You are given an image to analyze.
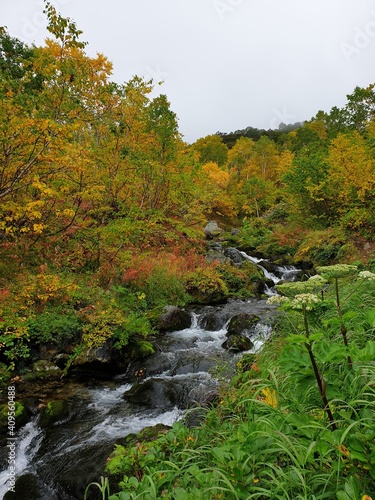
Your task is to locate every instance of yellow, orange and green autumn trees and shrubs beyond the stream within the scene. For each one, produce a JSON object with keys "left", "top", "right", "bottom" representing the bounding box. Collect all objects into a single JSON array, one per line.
[{"left": 0, "top": 2, "right": 375, "bottom": 378}]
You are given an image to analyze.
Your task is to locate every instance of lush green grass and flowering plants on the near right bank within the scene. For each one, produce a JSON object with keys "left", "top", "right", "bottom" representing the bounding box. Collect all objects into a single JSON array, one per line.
[{"left": 87, "top": 266, "right": 375, "bottom": 500}]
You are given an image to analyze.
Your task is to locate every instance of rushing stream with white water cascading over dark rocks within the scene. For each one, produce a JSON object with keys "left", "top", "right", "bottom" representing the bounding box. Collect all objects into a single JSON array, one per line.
[{"left": 0, "top": 252, "right": 299, "bottom": 500}]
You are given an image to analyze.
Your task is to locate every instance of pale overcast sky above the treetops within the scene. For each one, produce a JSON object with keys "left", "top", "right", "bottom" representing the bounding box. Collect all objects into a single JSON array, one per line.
[{"left": 0, "top": 0, "right": 375, "bottom": 142}]
